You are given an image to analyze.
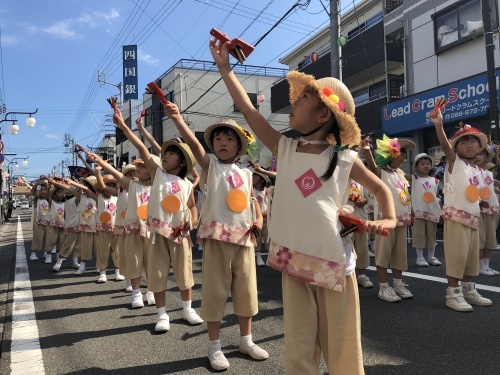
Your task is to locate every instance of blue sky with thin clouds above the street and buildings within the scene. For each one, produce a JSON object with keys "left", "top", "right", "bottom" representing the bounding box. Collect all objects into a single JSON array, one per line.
[{"left": 0, "top": 0, "right": 357, "bottom": 178}]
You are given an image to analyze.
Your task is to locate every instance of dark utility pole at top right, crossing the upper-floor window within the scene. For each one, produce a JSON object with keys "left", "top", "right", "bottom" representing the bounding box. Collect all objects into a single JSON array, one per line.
[{"left": 481, "top": 0, "right": 500, "bottom": 141}]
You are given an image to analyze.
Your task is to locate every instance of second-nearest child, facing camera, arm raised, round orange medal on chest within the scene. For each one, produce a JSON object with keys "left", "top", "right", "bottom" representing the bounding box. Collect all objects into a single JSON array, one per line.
[{"left": 165, "top": 103, "right": 269, "bottom": 370}]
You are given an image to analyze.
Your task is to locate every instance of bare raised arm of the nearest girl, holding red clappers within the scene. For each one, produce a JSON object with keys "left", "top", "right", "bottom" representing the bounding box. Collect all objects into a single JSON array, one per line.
[{"left": 210, "top": 40, "right": 282, "bottom": 155}]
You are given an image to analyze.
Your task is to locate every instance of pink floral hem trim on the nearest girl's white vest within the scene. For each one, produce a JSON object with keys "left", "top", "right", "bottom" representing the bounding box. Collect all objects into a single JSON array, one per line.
[{"left": 267, "top": 241, "right": 346, "bottom": 292}]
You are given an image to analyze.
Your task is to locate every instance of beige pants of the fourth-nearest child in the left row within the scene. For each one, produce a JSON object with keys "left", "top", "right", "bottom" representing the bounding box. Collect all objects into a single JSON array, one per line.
[{"left": 124, "top": 233, "right": 149, "bottom": 284}]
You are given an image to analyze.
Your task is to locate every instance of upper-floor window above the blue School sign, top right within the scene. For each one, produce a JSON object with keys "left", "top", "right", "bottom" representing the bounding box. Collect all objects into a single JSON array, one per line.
[{"left": 433, "top": 0, "right": 498, "bottom": 52}]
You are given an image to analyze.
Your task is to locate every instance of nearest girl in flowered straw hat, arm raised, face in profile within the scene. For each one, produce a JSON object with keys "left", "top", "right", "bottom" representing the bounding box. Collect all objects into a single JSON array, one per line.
[{"left": 210, "top": 36, "right": 396, "bottom": 374}]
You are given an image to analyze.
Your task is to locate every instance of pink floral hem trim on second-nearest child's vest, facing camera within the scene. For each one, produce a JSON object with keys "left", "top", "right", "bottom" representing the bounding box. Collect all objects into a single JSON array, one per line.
[{"left": 197, "top": 221, "right": 257, "bottom": 247}]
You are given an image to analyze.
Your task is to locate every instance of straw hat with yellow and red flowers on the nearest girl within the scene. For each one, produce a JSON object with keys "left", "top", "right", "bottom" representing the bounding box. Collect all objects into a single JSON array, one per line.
[{"left": 286, "top": 71, "right": 361, "bottom": 147}]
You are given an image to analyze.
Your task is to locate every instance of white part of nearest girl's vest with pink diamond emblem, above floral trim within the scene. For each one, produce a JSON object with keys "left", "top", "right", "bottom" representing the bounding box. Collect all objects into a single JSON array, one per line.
[{"left": 269, "top": 136, "right": 356, "bottom": 265}]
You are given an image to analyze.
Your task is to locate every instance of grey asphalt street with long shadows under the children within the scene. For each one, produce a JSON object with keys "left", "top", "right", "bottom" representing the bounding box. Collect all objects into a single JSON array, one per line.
[{"left": 0, "top": 210, "right": 500, "bottom": 375}]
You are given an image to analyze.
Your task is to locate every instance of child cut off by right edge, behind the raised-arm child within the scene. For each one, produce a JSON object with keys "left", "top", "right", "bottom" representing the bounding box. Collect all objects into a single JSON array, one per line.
[{"left": 475, "top": 145, "right": 500, "bottom": 276}]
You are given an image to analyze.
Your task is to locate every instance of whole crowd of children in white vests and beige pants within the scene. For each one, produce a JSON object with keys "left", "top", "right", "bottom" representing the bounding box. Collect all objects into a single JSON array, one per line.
[{"left": 18, "top": 36, "right": 500, "bottom": 374}]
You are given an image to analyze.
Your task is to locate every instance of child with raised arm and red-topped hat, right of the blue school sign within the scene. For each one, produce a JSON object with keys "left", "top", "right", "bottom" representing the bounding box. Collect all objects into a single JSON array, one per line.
[{"left": 430, "top": 108, "right": 492, "bottom": 311}]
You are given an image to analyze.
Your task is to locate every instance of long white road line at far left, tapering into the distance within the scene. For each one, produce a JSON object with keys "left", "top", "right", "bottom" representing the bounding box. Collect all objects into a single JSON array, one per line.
[{"left": 10, "top": 216, "right": 45, "bottom": 375}]
